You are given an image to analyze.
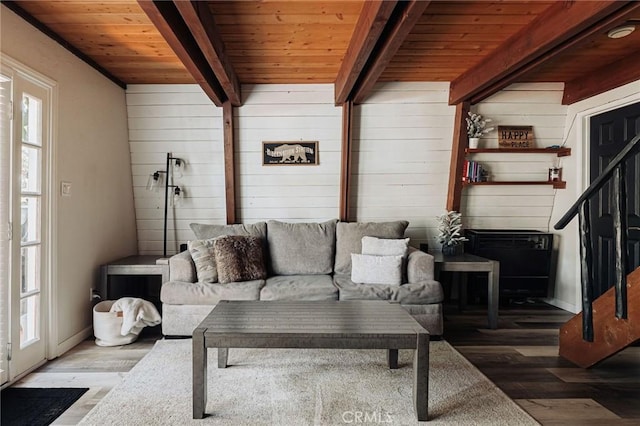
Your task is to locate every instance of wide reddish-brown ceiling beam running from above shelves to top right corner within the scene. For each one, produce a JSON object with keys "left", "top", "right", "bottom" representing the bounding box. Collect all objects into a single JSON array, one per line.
[{"left": 449, "top": 0, "right": 640, "bottom": 105}]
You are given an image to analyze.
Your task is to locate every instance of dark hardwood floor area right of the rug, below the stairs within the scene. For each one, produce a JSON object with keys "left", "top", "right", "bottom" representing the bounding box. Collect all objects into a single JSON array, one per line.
[{"left": 444, "top": 303, "right": 640, "bottom": 425}]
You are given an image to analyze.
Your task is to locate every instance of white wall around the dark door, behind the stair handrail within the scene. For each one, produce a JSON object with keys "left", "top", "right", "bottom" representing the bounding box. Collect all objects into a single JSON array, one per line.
[{"left": 551, "top": 81, "right": 640, "bottom": 312}]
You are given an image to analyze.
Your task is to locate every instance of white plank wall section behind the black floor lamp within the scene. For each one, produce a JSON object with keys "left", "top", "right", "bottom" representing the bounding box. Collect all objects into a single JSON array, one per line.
[{"left": 127, "top": 84, "right": 226, "bottom": 254}]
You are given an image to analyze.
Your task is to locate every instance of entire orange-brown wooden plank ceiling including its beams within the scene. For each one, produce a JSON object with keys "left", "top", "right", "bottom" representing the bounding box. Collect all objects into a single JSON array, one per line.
[{"left": 3, "top": 0, "right": 640, "bottom": 105}]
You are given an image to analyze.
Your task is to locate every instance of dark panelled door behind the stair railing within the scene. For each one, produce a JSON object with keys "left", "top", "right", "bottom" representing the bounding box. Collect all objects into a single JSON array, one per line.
[{"left": 590, "top": 103, "right": 640, "bottom": 297}]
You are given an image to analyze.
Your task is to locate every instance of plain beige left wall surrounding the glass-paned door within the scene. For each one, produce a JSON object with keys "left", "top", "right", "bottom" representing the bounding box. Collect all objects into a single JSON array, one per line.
[{"left": 0, "top": 6, "right": 137, "bottom": 356}]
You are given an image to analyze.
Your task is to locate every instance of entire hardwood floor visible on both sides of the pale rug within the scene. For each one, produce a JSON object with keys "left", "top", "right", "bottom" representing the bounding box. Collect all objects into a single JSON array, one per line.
[{"left": 10, "top": 303, "right": 640, "bottom": 425}]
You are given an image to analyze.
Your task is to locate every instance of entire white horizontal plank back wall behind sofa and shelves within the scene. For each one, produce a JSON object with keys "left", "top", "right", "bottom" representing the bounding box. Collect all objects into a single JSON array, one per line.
[{"left": 127, "top": 83, "right": 566, "bottom": 254}]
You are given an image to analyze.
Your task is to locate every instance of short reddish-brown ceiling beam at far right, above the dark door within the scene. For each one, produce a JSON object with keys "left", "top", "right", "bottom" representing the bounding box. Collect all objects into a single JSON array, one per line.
[{"left": 562, "top": 52, "right": 640, "bottom": 105}]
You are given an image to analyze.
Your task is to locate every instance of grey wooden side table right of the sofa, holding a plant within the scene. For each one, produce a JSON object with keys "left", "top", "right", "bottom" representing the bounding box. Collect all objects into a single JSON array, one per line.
[{"left": 429, "top": 251, "right": 500, "bottom": 329}]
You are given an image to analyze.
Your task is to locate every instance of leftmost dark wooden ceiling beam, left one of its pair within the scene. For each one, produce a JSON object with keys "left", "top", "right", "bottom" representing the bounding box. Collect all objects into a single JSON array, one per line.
[{"left": 138, "top": 0, "right": 227, "bottom": 107}]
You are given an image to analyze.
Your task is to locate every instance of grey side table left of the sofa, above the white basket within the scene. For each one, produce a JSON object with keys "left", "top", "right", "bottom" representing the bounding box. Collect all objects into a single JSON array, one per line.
[{"left": 99, "top": 255, "right": 169, "bottom": 300}]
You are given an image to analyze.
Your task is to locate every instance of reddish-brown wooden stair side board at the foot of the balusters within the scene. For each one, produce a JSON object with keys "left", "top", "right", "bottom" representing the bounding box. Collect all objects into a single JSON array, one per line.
[{"left": 560, "top": 268, "right": 640, "bottom": 368}]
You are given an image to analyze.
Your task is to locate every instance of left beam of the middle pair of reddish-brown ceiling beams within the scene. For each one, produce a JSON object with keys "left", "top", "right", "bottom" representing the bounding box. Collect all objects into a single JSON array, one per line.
[{"left": 335, "top": 0, "right": 398, "bottom": 105}]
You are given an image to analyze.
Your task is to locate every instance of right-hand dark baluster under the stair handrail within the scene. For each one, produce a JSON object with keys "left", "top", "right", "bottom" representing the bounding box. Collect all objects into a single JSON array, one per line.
[{"left": 611, "top": 161, "right": 628, "bottom": 319}]
